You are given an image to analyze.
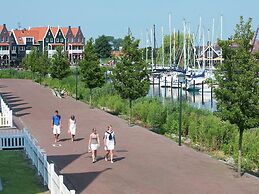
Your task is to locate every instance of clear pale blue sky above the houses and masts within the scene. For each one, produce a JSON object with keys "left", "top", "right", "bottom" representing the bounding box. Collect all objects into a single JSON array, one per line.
[{"left": 0, "top": 0, "right": 259, "bottom": 44}]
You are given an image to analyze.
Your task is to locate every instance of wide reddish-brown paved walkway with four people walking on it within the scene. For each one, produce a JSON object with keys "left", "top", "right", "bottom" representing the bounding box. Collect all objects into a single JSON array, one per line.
[{"left": 0, "top": 80, "right": 259, "bottom": 194}]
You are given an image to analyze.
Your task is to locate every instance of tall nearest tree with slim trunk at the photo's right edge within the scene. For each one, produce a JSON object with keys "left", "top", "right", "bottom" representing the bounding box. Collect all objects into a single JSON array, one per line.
[{"left": 215, "top": 17, "right": 259, "bottom": 174}]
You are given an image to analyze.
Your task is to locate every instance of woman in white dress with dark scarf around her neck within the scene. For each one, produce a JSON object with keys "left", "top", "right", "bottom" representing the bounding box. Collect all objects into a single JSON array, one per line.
[{"left": 103, "top": 125, "right": 116, "bottom": 163}]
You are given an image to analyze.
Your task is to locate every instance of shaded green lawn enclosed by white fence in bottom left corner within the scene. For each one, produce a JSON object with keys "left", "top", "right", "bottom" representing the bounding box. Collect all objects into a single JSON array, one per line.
[{"left": 0, "top": 151, "right": 49, "bottom": 194}]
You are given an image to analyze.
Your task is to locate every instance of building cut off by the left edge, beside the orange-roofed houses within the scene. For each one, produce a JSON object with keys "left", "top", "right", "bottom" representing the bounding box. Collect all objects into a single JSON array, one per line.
[{"left": 0, "top": 24, "right": 10, "bottom": 65}]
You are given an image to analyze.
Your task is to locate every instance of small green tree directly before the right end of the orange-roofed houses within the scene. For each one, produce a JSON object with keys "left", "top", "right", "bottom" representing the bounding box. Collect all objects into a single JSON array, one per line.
[{"left": 50, "top": 47, "right": 70, "bottom": 89}]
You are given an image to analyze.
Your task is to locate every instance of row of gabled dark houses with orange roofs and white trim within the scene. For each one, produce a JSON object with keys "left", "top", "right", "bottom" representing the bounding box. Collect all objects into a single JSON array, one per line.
[{"left": 10, "top": 26, "right": 85, "bottom": 64}]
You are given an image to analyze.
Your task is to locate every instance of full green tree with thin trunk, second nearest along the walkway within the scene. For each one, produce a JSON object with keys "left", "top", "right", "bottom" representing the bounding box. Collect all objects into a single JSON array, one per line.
[{"left": 112, "top": 35, "right": 149, "bottom": 124}]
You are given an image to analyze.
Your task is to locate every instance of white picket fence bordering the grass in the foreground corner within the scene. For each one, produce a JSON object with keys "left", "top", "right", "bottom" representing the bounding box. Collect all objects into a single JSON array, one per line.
[{"left": 0, "top": 129, "right": 75, "bottom": 194}]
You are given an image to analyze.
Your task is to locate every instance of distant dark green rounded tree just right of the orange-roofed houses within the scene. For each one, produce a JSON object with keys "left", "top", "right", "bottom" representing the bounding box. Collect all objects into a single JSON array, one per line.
[{"left": 94, "top": 35, "right": 112, "bottom": 58}]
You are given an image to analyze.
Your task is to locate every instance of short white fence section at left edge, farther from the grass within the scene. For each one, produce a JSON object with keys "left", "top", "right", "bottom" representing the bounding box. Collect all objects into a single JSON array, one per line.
[{"left": 0, "top": 96, "right": 13, "bottom": 127}]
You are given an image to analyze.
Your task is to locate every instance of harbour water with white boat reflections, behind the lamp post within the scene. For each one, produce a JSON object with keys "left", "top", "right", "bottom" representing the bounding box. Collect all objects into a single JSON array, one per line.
[{"left": 148, "top": 85, "right": 217, "bottom": 112}]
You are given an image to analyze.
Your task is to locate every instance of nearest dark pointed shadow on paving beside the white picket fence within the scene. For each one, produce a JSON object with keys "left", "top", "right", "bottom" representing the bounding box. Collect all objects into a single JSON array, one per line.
[{"left": 63, "top": 168, "right": 112, "bottom": 193}]
